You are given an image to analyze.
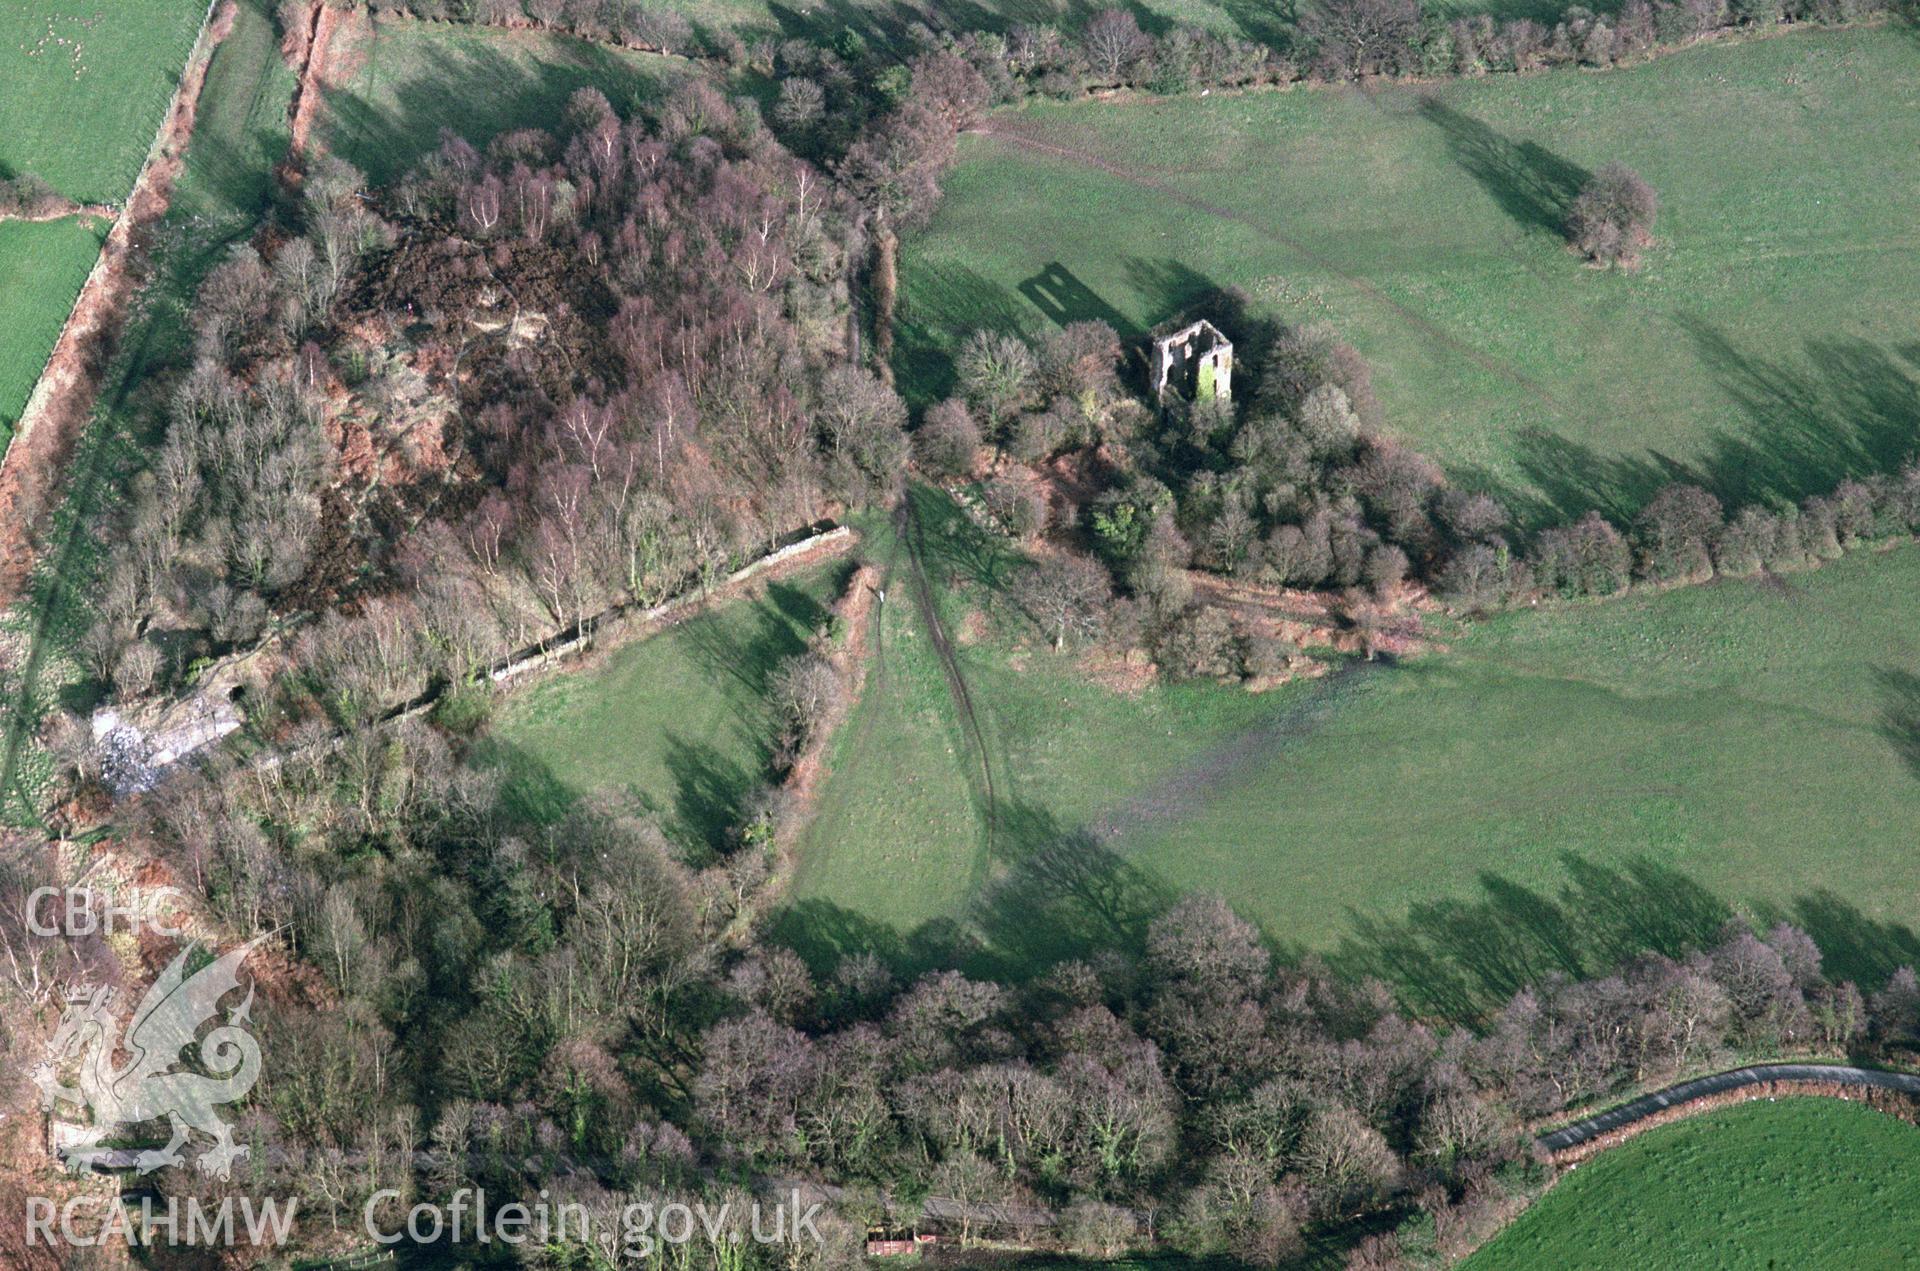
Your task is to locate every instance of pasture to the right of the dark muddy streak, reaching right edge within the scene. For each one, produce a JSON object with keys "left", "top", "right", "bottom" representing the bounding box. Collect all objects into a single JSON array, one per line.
[{"left": 1121, "top": 547, "right": 1920, "bottom": 1012}]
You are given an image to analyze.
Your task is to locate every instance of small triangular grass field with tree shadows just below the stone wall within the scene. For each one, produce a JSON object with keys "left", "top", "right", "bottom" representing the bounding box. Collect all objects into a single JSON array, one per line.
[{"left": 484, "top": 564, "right": 847, "bottom": 851}]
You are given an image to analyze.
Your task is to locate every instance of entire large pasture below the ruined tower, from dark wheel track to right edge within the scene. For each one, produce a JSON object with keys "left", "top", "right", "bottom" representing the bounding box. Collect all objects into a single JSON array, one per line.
[{"left": 785, "top": 487, "right": 1920, "bottom": 1016}]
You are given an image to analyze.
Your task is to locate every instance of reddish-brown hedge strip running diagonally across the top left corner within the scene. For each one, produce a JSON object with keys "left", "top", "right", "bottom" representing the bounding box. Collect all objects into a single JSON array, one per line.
[{"left": 0, "top": 0, "right": 234, "bottom": 603}]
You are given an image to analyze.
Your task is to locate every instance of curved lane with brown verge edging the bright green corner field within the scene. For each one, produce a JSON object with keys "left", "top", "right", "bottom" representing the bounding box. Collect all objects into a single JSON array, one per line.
[{"left": 1534, "top": 1064, "right": 1920, "bottom": 1163}]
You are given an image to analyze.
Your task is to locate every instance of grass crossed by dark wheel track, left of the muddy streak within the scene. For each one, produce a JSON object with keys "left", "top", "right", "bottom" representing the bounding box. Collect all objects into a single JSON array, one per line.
[{"left": 785, "top": 490, "right": 1275, "bottom": 973}]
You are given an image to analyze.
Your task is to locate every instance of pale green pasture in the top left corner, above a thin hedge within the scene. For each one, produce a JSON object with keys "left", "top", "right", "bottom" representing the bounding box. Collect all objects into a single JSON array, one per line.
[{"left": 0, "top": 0, "right": 207, "bottom": 204}]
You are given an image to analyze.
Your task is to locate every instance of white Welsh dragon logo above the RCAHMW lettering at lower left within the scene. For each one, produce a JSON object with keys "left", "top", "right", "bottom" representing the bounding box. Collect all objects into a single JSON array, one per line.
[{"left": 33, "top": 937, "right": 265, "bottom": 1179}]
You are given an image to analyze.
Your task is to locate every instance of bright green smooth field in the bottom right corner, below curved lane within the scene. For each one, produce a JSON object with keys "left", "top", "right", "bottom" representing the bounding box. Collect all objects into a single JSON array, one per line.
[{"left": 1465, "top": 1098, "right": 1920, "bottom": 1271}]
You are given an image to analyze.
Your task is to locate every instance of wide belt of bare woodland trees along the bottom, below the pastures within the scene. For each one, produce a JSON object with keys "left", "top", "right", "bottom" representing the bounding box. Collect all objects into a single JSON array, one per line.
[{"left": 18, "top": 710, "right": 1920, "bottom": 1271}]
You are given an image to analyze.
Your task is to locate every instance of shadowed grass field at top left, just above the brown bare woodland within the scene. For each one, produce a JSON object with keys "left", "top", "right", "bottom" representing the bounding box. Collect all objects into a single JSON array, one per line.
[{"left": 319, "top": 21, "right": 687, "bottom": 184}]
